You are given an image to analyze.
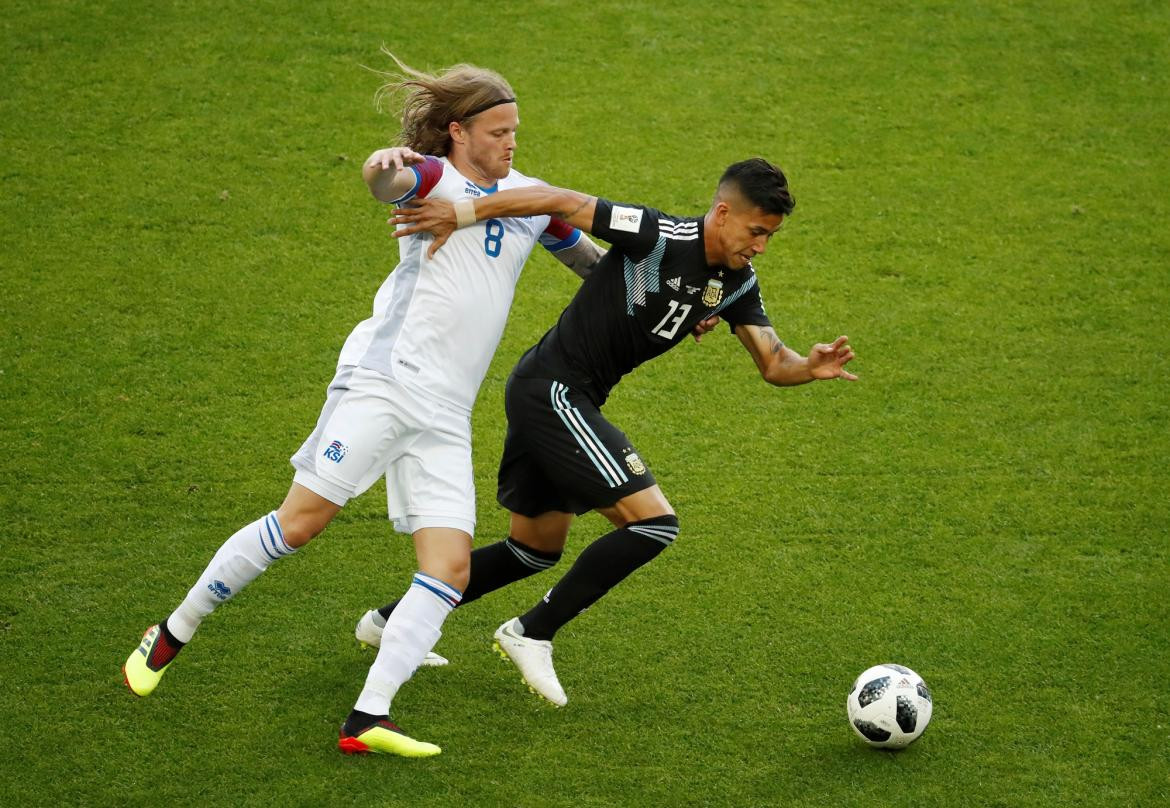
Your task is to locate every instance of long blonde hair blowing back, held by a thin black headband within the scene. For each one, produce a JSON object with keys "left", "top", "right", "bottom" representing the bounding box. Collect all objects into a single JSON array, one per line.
[{"left": 374, "top": 47, "right": 515, "bottom": 157}]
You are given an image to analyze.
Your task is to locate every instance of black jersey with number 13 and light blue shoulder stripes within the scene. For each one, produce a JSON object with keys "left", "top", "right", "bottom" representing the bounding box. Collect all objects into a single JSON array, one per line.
[{"left": 514, "top": 199, "right": 771, "bottom": 407}]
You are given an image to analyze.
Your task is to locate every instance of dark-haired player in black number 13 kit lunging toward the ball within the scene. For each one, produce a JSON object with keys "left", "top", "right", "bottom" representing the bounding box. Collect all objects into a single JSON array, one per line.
[{"left": 379, "top": 158, "right": 856, "bottom": 705}]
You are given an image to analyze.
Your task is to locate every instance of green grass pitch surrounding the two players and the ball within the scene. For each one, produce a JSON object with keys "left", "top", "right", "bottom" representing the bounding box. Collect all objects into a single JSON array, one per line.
[{"left": 0, "top": 0, "right": 1170, "bottom": 808}]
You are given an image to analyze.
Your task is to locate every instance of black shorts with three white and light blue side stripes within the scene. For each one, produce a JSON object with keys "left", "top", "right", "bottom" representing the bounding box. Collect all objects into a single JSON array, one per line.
[{"left": 496, "top": 375, "right": 656, "bottom": 517}]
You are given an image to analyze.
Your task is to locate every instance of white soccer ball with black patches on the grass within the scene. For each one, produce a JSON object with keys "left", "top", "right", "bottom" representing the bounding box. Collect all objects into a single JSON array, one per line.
[{"left": 845, "top": 663, "right": 934, "bottom": 750}]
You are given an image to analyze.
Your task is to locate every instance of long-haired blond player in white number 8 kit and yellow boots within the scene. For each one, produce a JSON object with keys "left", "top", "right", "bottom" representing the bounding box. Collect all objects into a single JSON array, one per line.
[{"left": 123, "top": 58, "right": 603, "bottom": 757}]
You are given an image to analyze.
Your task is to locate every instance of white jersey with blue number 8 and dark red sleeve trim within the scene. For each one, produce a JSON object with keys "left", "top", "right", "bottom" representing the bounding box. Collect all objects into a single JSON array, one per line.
[{"left": 338, "top": 157, "right": 580, "bottom": 412}]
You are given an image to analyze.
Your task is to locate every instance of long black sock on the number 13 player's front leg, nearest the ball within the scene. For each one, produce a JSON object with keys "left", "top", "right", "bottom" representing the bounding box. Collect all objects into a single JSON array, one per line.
[{"left": 519, "top": 516, "right": 679, "bottom": 640}]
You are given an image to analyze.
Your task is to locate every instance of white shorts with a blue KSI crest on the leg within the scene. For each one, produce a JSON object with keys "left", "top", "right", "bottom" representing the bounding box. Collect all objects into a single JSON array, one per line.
[{"left": 291, "top": 366, "right": 475, "bottom": 534}]
